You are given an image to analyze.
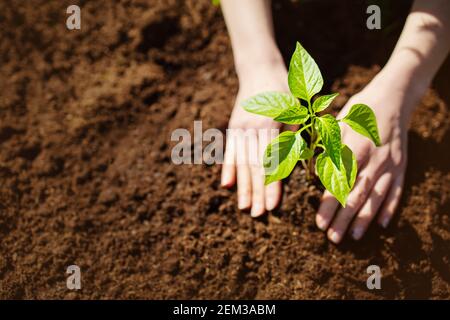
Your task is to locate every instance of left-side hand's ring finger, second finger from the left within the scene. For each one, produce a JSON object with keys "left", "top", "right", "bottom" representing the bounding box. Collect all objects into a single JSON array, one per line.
[{"left": 236, "top": 134, "right": 252, "bottom": 210}]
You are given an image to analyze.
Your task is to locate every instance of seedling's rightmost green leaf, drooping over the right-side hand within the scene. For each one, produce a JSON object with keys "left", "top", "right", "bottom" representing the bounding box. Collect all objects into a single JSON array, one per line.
[{"left": 342, "top": 104, "right": 381, "bottom": 147}]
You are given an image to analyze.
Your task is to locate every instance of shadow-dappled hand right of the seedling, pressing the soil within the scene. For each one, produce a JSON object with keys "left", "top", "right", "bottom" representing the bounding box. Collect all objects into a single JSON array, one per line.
[{"left": 316, "top": 71, "right": 420, "bottom": 244}]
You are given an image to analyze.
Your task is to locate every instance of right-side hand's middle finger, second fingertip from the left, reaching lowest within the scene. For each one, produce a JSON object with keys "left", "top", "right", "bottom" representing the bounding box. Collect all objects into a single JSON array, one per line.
[{"left": 327, "top": 170, "right": 376, "bottom": 244}]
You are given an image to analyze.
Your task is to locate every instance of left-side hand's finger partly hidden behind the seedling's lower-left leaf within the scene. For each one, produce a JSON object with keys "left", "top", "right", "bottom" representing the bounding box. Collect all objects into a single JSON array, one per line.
[{"left": 258, "top": 129, "right": 282, "bottom": 211}]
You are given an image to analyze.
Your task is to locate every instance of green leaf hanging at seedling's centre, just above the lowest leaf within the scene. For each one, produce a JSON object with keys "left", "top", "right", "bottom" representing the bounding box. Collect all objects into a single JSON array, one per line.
[{"left": 316, "top": 114, "right": 341, "bottom": 168}]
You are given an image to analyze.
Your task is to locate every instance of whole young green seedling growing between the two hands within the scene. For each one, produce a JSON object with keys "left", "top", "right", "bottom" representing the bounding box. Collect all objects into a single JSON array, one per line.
[{"left": 242, "top": 42, "right": 381, "bottom": 207}]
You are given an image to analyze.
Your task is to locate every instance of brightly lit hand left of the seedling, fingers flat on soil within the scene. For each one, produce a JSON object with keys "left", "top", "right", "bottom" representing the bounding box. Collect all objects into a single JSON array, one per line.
[{"left": 221, "top": 63, "right": 289, "bottom": 217}]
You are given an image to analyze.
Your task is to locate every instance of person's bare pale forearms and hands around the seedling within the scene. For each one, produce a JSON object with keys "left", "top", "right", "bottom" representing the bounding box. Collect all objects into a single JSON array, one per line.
[{"left": 221, "top": 0, "right": 450, "bottom": 244}]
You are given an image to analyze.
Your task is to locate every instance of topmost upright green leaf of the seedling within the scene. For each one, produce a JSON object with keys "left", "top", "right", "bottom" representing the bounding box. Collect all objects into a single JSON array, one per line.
[{"left": 288, "top": 42, "right": 323, "bottom": 101}]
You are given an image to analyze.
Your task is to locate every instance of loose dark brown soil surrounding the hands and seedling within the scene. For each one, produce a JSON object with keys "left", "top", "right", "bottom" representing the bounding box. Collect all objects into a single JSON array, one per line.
[{"left": 0, "top": 0, "right": 450, "bottom": 299}]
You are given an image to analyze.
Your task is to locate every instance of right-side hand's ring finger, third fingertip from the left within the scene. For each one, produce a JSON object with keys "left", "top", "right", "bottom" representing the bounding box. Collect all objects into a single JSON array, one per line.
[{"left": 351, "top": 172, "right": 392, "bottom": 240}]
